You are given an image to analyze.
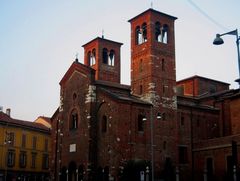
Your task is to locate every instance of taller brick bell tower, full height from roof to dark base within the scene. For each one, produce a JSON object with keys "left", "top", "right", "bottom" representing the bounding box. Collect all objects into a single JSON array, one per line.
[{"left": 129, "top": 9, "right": 177, "bottom": 171}]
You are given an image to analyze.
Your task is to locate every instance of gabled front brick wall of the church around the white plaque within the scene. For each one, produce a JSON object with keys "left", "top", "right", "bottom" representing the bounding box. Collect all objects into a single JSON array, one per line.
[{"left": 59, "top": 71, "right": 91, "bottom": 174}]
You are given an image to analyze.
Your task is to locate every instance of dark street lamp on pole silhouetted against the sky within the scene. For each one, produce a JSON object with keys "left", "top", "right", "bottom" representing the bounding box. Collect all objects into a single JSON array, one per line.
[{"left": 213, "top": 29, "right": 240, "bottom": 86}]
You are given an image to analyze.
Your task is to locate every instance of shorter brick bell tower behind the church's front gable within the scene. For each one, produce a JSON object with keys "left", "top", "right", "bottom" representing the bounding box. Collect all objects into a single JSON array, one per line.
[{"left": 83, "top": 37, "right": 122, "bottom": 83}]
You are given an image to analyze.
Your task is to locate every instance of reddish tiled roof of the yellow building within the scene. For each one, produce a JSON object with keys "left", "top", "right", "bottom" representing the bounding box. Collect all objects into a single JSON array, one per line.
[{"left": 0, "top": 112, "right": 50, "bottom": 133}]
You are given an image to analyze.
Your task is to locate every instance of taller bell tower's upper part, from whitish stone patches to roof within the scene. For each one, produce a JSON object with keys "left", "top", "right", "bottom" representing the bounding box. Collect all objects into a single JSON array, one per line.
[{"left": 129, "top": 9, "right": 177, "bottom": 99}]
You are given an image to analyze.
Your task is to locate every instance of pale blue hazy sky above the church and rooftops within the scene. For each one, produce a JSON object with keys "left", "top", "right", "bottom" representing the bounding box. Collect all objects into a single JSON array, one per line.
[{"left": 0, "top": 0, "right": 240, "bottom": 121}]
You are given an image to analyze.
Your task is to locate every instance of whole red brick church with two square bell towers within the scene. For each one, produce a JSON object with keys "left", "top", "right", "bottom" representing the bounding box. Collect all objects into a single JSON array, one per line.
[{"left": 50, "top": 9, "right": 240, "bottom": 181}]
